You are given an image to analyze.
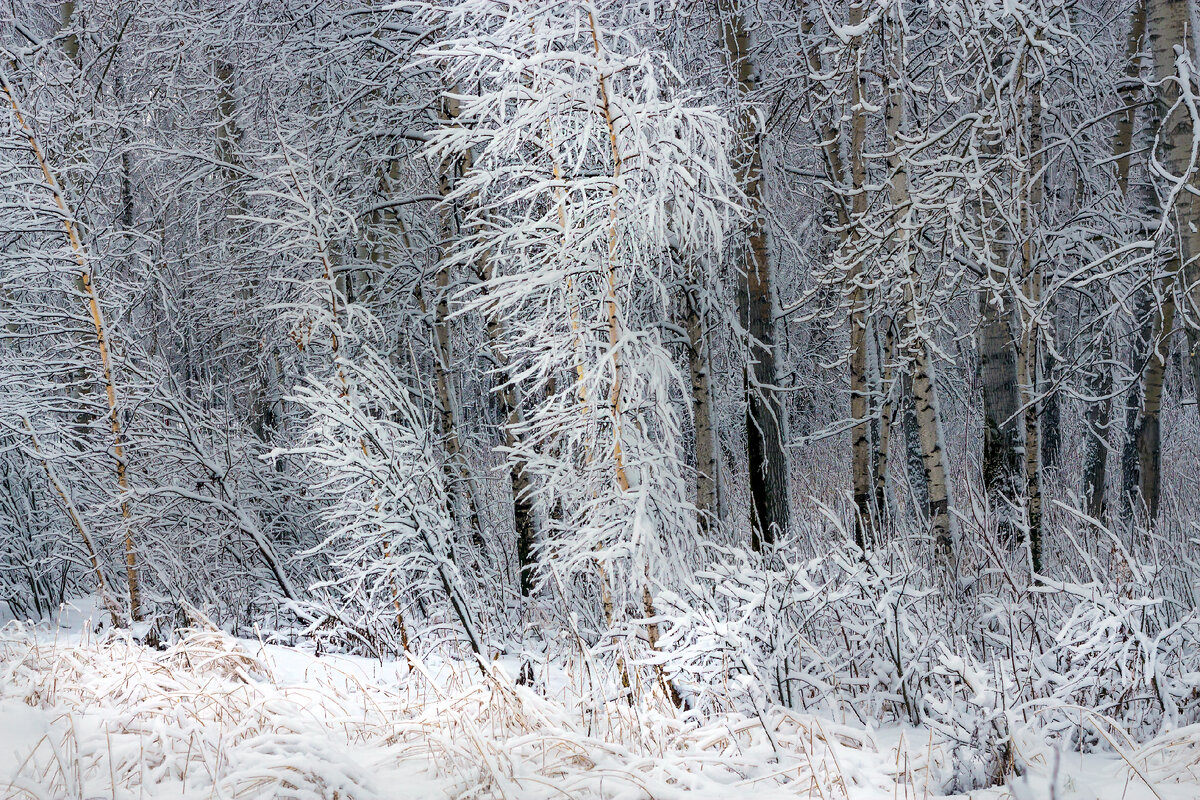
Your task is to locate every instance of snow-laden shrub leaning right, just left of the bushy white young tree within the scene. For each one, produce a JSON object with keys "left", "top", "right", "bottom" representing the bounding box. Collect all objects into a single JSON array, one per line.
[{"left": 288, "top": 347, "right": 482, "bottom": 655}]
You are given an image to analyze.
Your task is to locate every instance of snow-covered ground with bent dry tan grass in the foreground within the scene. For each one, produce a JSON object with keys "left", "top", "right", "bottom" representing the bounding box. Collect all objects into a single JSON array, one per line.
[{"left": 0, "top": 604, "right": 1200, "bottom": 800}]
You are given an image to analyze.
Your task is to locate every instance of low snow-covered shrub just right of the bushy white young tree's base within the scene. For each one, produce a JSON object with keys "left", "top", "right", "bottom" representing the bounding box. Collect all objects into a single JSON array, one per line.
[{"left": 664, "top": 527, "right": 938, "bottom": 722}]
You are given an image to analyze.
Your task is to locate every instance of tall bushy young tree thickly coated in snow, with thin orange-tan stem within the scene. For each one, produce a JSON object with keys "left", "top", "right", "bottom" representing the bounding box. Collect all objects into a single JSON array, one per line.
[{"left": 428, "top": 2, "right": 732, "bottom": 703}]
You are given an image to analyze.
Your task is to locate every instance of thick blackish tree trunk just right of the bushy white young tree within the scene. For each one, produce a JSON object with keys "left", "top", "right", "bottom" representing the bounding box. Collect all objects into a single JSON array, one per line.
[{"left": 718, "top": 0, "right": 790, "bottom": 551}]
